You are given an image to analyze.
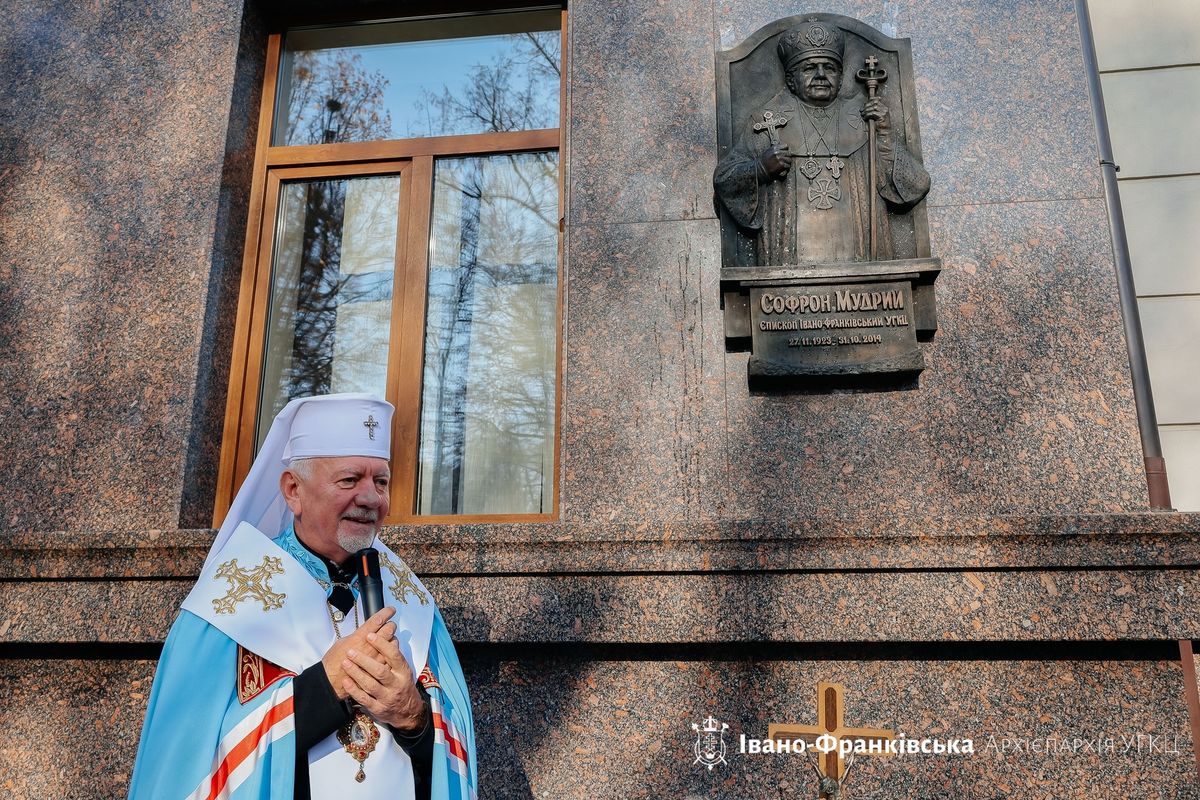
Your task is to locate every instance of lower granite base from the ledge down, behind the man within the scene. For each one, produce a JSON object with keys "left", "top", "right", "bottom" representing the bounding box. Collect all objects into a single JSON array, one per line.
[{"left": 7, "top": 513, "right": 1200, "bottom": 800}]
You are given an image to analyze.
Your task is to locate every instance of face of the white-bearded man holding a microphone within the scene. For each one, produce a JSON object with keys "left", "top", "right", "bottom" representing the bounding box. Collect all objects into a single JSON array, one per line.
[{"left": 280, "top": 456, "right": 391, "bottom": 561}]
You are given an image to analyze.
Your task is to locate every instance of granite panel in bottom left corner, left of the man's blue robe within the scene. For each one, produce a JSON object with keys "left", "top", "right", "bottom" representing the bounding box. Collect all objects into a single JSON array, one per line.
[{"left": 0, "top": 660, "right": 155, "bottom": 800}]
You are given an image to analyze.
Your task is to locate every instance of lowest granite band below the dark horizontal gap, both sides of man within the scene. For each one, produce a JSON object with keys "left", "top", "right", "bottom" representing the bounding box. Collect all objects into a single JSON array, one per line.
[{"left": 7, "top": 648, "right": 1200, "bottom": 800}]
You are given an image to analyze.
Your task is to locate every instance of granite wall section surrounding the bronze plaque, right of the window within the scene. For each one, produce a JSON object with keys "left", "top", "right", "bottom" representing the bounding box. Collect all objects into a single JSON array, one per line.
[{"left": 562, "top": 0, "right": 1147, "bottom": 522}]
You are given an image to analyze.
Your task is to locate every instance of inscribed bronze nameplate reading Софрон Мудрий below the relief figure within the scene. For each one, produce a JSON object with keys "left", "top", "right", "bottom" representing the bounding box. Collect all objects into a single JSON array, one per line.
[{"left": 750, "top": 281, "right": 923, "bottom": 377}]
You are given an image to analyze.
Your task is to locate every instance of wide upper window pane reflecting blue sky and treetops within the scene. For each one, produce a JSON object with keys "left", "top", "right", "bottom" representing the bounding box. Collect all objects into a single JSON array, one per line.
[{"left": 272, "top": 10, "right": 560, "bottom": 145}]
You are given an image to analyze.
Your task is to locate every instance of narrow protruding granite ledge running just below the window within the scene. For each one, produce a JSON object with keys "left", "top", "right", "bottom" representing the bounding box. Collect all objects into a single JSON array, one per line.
[{"left": 0, "top": 512, "right": 1200, "bottom": 581}]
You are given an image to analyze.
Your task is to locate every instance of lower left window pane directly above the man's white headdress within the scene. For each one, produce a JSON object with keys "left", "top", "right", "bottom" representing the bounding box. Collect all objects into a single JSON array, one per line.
[{"left": 256, "top": 175, "right": 401, "bottom": 450}]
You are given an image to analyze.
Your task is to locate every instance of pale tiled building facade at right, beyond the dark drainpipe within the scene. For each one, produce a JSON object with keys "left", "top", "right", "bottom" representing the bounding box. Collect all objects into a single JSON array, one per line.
[{"left": 1090, "top": 0, "right": 1200, "bottom": 511}]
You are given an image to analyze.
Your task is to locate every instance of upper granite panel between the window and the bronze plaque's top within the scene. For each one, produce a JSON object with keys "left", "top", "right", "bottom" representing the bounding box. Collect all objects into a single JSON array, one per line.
[{"left": 568, "top": 0, "right": 716, "bottom": 224}]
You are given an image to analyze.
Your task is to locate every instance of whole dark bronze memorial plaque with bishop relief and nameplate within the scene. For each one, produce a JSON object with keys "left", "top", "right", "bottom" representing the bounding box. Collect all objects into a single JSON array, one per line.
[{"left": 713, "top": 13, "right": 941, "bottom": 385}]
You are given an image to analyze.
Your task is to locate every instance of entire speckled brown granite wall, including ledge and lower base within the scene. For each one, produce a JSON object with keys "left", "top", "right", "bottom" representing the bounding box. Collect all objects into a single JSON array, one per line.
[{"left": 0, "top": 0, "right": 1200, "bottom": 800}]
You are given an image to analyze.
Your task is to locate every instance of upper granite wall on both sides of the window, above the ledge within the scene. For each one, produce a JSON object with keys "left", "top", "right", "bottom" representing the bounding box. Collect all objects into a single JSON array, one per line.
[{"left": 0, "top": 0, "right": 1147, "bottom": 531}]
